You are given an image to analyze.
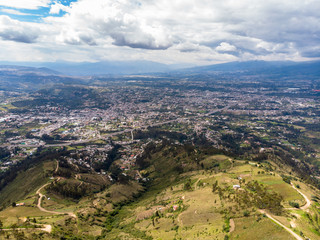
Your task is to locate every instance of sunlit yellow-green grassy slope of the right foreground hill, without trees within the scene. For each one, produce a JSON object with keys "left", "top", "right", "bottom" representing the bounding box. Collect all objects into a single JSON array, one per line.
[{"left": 102, "top": 156, "right": 312, "bottom": 239}]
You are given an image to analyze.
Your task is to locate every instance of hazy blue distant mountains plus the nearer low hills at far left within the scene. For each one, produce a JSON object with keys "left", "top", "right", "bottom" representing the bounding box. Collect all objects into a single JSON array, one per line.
[{"left": 0, "top": 61, "right": 320, "bottom": 91}]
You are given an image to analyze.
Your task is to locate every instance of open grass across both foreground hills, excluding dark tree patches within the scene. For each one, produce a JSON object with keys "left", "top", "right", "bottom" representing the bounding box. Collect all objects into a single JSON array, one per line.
[{"left": 0, "top": 149, "right": 318, "bottom": 239}]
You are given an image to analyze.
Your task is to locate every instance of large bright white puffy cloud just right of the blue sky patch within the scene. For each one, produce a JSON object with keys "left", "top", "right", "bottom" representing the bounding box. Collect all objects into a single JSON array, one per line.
[{"left": 47, "top": 0, "right": 172, "bottom": 49}]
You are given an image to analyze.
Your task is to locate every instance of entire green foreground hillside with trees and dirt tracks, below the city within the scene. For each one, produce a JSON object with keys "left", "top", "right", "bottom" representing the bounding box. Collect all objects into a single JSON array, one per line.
[{"left": 0, "top": 142, "right": 320, "bottom": 239}]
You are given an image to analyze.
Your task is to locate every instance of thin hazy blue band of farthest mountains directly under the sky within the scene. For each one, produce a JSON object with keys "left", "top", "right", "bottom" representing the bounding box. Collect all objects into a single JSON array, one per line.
[{"left": 0, "top": 61, "right": 320, "bottom": 76}]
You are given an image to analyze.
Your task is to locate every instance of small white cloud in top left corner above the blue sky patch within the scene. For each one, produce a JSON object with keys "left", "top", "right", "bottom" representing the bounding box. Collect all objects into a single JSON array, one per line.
[{"left": 0, "top": 0, "right": 52, "bottom": 9}]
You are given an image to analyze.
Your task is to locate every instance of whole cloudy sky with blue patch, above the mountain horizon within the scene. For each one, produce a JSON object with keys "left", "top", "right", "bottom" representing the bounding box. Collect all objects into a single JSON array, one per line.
[{"left": 0, "top": 0, "right": 320, "bottom": 65}]
